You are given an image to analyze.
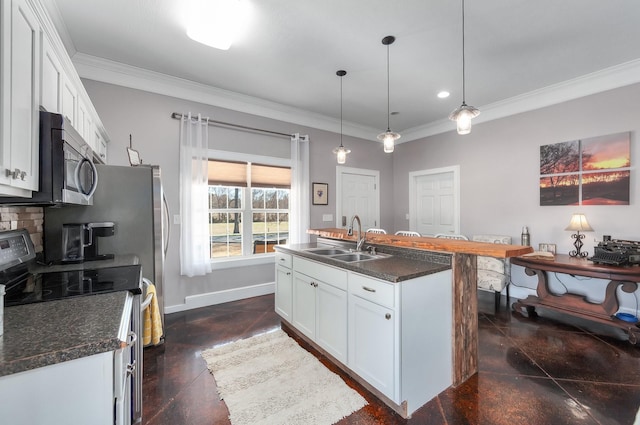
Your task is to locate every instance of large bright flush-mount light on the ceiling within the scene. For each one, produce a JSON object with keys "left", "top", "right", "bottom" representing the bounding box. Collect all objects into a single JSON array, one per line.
[{"left": 187, "top": 0, "right": 249, "bottom": 50}]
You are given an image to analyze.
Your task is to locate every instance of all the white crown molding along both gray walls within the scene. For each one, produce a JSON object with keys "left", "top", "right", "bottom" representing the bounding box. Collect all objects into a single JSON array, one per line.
[{"left": 72, "top": 53, "right": 640, "bottom": 144}]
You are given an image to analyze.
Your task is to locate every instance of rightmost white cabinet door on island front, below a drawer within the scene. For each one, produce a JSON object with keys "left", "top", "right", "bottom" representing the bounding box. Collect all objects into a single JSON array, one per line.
[{"left": 348, "top": 295, "right": 397, "bottom": 402}]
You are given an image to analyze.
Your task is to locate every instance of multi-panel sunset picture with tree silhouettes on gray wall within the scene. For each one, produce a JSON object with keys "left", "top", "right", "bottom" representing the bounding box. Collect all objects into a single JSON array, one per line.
[{"left": 540, "top": 132, "right": 631, "bottom": 206}]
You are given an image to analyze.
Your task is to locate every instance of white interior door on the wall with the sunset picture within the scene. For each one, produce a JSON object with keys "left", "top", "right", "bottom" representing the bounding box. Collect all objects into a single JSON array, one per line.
[{"left": 409, "top": 166, "right": 460, "bottom": 236}]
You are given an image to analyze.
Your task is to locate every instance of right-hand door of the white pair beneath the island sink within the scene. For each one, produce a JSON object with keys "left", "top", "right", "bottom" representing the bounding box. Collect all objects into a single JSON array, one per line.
[{"left": 316, "top": 282, "right": 347, "bottom": 363}]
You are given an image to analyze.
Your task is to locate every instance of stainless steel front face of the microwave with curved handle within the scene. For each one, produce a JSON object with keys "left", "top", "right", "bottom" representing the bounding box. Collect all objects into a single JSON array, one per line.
[{"left": 62, "top": 141, "right": 98, "bottom": 205}]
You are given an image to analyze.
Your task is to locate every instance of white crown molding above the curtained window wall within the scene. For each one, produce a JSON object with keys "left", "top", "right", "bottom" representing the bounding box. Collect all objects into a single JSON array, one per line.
[{"left": 72, "top": 53, "right": 377, "bottom": 140}]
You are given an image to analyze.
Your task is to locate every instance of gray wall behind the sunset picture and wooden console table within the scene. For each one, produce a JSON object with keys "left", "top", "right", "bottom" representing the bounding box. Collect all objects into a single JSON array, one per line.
[{"left": 393, "top": 85, "right": 640, "bottom": 313}]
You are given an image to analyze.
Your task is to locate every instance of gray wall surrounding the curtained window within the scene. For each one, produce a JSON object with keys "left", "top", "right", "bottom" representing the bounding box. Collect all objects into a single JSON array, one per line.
[{"left": 83, "top": 80, "right": 394, "bottom": 311}]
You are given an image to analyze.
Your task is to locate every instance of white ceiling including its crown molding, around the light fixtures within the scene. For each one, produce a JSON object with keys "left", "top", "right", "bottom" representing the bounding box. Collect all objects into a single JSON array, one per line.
[{"left": 43, "top": 0, "right": 640, "bottom": 142}]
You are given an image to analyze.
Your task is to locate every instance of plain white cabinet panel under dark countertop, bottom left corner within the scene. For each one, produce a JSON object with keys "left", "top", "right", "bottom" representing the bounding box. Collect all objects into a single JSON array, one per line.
[{"left": 0, "top": 352, "right": 114, "bottom": 425}]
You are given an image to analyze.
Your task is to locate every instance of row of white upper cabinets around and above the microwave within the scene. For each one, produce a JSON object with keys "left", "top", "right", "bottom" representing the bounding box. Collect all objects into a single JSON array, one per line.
[{"left": 0, "top": 0, "right": 109, "bottom": 197}]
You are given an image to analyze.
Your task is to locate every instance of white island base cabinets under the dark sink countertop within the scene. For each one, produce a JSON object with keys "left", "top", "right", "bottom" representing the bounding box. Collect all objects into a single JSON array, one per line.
[{"left": 276, "top": 248, "right": 453, "bottom": 417}]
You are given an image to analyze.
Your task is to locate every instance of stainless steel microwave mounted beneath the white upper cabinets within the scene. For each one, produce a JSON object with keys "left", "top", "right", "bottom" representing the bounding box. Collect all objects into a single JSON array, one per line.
[{"left": 0, "top": 111, "right": 98, "bottom": 205}]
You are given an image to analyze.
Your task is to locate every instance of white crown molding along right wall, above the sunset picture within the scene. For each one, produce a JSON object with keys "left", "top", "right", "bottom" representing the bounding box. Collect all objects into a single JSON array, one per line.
[{"left": 400, "top": 59, "right": 640, "bottom": 143}]
